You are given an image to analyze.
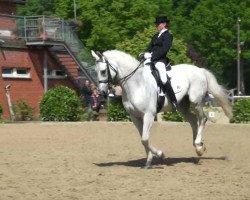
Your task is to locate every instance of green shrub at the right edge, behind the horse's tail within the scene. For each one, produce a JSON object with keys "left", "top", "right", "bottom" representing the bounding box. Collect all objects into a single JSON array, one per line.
[{"left": 231, "top": 99, "right": 250, "bottom": 123}]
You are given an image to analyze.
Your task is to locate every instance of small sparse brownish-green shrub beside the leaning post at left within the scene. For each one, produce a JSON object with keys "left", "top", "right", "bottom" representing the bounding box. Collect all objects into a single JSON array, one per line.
[{"left": 13, "top": 99, "right": 35, "bottom": 121}]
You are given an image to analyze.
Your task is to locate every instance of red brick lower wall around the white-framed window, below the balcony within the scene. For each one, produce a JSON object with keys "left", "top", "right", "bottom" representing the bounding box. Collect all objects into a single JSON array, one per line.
[{"left": 0, "top": 48, "right": 74, "bottom": 118}]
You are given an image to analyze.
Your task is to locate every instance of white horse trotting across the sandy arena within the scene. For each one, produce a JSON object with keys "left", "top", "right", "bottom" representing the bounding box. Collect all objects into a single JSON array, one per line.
[{"left": 92, "top": 50, "right": 232, "bottom": 168}]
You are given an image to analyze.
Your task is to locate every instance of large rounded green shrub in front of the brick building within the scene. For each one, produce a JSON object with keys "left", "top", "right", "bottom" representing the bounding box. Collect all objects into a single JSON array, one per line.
[{"left": 40, "top": 86, "right": 82, "bottom": 121}]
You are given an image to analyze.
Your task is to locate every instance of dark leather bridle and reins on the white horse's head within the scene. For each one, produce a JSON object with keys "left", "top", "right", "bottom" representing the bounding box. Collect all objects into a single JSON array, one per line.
[{"left": 97, "top": 52, "right": 143, "bottom": 84}]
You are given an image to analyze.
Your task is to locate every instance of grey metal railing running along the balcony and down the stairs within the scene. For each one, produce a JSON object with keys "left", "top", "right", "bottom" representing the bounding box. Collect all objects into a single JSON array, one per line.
[{"left": 0, "top": 14, "right": 96, "bottom": 82}]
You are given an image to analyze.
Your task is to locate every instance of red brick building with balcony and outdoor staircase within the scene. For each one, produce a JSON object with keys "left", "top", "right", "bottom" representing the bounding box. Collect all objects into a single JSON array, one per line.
[{"left": 0, "top": 0, "right": 96, "bottom": 118}]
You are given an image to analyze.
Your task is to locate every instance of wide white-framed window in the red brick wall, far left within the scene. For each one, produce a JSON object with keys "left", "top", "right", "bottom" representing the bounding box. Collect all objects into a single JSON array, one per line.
[{"left": 2, "top": 67, "right": 30, "bottom": 78}]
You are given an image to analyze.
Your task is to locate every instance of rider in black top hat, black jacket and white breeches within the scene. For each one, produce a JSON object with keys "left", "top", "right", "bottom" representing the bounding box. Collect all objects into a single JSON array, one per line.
[{"left": 144, "top": 16, "right": 177, "bottom": 111}]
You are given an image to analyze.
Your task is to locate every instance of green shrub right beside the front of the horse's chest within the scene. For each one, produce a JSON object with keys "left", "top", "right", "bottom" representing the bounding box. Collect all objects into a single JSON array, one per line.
[{"left": 108, "top": 97, "right": 131, "bottom": 121}]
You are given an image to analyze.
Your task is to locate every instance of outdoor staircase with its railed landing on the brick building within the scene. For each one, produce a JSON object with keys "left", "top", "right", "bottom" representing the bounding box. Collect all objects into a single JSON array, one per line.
[{"left": 19, "top": 16, "right": 97, "bottom": 85}]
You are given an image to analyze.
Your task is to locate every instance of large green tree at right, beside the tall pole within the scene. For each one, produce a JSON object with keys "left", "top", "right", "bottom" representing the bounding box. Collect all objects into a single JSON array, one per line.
[{"left": 176, "top": 0, "right": 250, "bottom": 87}]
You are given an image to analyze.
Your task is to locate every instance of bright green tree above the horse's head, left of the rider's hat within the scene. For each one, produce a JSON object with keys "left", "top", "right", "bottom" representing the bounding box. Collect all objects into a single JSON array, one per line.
[{"left": 67, "top": 0, "right": 159, "bottom": 51}]
